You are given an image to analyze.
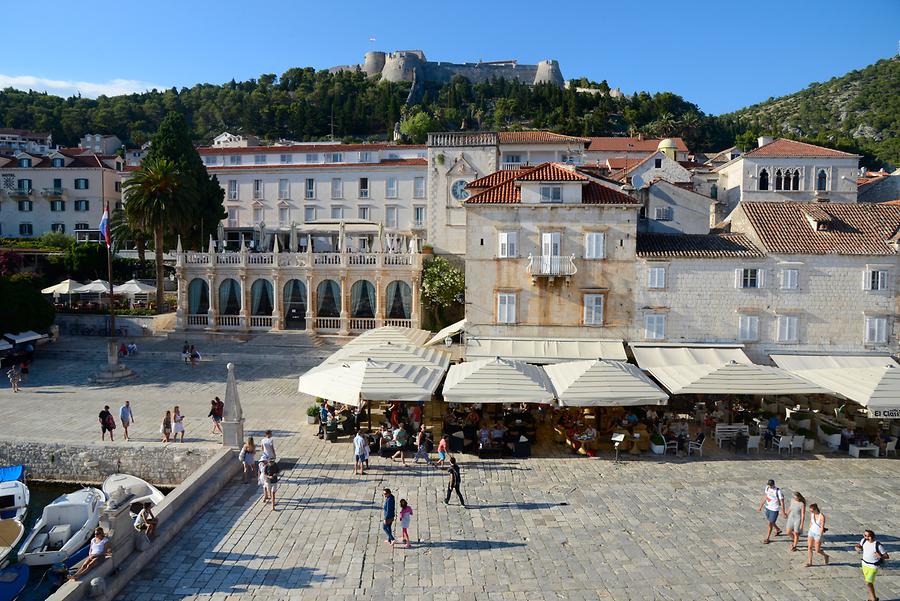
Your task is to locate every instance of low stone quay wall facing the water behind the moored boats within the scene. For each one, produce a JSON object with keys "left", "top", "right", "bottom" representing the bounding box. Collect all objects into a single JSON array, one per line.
[{"left": 0, "top": 440, "right": 221, "bottom": 486}]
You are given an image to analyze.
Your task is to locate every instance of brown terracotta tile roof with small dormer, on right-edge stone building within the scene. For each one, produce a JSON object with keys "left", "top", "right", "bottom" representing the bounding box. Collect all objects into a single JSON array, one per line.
[{"left": 737, "top": 202, "right": 900, "bottom": 255}]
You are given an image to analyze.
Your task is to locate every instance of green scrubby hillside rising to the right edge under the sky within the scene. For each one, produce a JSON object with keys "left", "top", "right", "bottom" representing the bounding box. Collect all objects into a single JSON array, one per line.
[{"left": 728, "top": 57, "right": 900, "bottom": 166}]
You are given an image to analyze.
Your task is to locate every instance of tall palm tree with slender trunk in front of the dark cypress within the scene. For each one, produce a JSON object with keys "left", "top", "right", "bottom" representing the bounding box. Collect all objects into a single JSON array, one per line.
[{"left": 123, "top": 158, "right": 194, "bottom": 311}]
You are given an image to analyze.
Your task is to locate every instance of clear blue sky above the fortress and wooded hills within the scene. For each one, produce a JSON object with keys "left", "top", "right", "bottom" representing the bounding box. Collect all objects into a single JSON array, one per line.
[{"left": 0, "top": 0, "right": 900, "bottom": 114}]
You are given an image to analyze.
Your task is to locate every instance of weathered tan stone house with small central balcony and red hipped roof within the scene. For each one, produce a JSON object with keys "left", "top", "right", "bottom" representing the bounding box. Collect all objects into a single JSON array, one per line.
[{"left": 465, "top": 163, "right": 640, "bottom": 340}]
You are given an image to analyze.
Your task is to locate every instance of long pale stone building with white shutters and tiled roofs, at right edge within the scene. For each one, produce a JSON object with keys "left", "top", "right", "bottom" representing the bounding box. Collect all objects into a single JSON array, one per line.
[{"left": 632, "top": 201, "right": 900, "bottom": 362}]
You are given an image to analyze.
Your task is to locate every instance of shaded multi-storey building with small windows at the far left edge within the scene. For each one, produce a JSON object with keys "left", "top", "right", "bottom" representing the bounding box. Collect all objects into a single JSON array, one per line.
[{"left": 0, "top": 150, "right": 123, "bottom": 240}]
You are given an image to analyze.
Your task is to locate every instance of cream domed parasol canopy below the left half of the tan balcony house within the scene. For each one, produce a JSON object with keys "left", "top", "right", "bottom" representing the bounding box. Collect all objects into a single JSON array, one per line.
[{"left": 443, "top": 357, "right": 555, "bottom": 403}]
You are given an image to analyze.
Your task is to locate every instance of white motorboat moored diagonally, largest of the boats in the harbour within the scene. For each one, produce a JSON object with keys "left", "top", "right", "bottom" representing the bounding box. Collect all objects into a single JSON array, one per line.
[{"left": 19, "top": 488, "right": 106, "bottom": 566}]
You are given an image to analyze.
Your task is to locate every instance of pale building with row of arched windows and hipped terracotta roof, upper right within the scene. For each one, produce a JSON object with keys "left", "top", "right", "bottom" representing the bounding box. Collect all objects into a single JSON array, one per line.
[{"left": 715, "top": 138, "right": 859, "bottom": 214}]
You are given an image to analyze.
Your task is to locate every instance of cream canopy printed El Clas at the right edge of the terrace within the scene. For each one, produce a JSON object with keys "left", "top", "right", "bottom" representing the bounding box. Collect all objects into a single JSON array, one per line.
[{"left": 771, "top": 355, "right": 900, "bottom": 418}]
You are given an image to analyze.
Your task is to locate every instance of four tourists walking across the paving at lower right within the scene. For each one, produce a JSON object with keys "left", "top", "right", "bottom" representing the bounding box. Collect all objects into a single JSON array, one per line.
[{"left": 757, "top": 480, "right": 890, "bottom": 601}]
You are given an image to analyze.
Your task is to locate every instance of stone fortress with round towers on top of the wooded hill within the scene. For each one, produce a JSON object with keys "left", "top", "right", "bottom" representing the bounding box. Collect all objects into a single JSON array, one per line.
[{"left": 329, "top": 50, "right": 564, "bottom": 87}]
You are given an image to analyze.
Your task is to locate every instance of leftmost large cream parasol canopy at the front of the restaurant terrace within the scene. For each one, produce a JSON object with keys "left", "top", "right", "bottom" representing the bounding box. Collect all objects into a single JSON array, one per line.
[{"left": 297, "top": 361, "right": 444, "bottom": 406}]
